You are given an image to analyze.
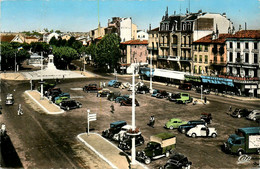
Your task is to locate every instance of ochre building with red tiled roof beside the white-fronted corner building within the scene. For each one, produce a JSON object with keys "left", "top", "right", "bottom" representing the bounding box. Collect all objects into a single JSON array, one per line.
[{"left": 192, "top": 31, "right": 232, "bottom": 75}]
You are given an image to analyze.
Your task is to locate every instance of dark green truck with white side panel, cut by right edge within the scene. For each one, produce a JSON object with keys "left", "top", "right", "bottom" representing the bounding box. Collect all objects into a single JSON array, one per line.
[{"left": 224, "top": 127, "right": 260, "bottom": 156}]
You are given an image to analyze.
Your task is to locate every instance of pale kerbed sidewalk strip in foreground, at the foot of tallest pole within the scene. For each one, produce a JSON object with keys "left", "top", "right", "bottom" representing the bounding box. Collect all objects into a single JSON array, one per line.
[{"left": 77, "top": 133, "right": 147, "bottom": 169}]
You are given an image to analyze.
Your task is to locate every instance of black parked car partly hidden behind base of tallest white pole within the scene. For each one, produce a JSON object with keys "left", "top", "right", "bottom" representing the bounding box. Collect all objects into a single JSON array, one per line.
[{"left": 118, "top": 134, "right": 144, "bottom": 150}]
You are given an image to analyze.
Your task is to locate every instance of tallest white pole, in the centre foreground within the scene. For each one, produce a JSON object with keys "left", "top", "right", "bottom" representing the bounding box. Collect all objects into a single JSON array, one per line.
[{"left": 131, "top": 68, "right": 136, "bottom": 165}]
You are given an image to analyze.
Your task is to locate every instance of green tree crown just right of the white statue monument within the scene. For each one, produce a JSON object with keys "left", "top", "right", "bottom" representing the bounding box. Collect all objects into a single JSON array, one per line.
[{"left": 53, "top": 46, "right": 78, "bottom": 69}]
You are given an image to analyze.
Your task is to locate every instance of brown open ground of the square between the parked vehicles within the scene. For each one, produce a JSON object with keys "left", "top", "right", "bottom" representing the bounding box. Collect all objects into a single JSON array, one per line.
[{"left": 53, "top": 78, "right": 259, "bottom": 168}]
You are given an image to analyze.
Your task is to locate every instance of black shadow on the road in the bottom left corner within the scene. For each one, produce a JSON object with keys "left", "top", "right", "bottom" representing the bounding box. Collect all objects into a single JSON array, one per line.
[{"left": 0, "top": 135, "right": 23, "bottom": 168}]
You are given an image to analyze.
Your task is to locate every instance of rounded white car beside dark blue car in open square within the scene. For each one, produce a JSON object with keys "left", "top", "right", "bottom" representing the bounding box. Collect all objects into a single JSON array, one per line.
[{"left": 187, "top": 125, "right": 217, "bottom": 138}]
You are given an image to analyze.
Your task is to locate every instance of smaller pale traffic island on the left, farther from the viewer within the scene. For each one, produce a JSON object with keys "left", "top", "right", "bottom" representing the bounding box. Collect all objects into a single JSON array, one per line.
[{"left": 25, "top": 90, "right": 64, "bottom": 114}]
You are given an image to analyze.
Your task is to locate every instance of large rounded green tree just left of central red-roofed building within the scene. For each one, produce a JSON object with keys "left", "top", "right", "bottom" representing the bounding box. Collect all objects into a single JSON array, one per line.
[{"left": 94, "top": 34, "right": 121, "bottom": 72}]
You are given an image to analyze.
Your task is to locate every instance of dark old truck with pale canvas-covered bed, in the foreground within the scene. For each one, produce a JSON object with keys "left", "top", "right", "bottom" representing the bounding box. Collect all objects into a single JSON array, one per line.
[{"left": 136, "top": 133, "right": 176, "bottom": 164}]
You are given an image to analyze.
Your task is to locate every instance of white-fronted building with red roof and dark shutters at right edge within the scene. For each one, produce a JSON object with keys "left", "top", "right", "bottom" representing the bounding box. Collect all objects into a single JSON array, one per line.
[{"left": 226, "top": 30, "right": 260, "bottom": 97}]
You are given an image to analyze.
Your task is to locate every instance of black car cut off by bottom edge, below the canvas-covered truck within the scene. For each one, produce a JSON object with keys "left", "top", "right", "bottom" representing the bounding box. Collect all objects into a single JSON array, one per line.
[{"left": 160, "top": 153, "right": 192, "bottom": 169}]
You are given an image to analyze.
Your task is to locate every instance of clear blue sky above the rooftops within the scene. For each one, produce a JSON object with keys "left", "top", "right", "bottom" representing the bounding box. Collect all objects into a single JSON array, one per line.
[{"left": 0, "top": 0, "right": 260, "bottom": 32}]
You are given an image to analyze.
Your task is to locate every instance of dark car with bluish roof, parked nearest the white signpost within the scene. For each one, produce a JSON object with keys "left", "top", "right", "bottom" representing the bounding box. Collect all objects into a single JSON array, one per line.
[{"left": 102, "top": 121, "right": 127, "bottom": 138}]
